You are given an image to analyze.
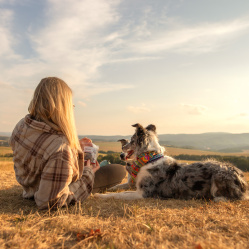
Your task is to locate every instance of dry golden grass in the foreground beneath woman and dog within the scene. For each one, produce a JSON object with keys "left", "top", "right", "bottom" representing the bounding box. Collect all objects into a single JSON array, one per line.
[{"left": 0, "top": 162, "right": 249, "bottom": 249}]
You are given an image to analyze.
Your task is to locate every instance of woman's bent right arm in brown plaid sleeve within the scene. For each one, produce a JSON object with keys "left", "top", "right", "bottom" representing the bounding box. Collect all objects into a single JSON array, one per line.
[{"left": 34, "top": 147, "right": 94, "bottom": 209}]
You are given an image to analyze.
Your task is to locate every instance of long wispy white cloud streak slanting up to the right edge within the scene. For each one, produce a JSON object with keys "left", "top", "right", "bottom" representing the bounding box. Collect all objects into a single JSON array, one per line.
[{"left": 126, "top": 18, "right": 249, "bottom": 54}]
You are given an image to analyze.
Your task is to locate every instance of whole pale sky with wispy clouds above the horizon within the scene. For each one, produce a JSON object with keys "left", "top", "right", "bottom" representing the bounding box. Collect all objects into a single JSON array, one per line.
[{"left": 0, "top": 0, "right": 249, "bottom": 135}]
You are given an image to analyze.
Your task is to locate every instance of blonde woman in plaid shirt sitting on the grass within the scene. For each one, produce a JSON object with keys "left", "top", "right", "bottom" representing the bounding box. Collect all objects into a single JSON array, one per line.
[{"left": 10, "top": 77, "right": 125, "bottom": 209}]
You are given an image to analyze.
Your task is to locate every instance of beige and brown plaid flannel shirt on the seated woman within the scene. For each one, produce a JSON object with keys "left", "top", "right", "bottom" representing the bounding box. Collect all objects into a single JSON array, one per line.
[{"left": 10, "top": 115, "right": 94, "bottom": 209}]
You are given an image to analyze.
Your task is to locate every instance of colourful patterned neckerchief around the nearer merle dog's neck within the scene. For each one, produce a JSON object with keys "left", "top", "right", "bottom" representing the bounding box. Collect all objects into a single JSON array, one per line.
[{"left": 130, "top": 151, "right": 164, "bottom": 183}]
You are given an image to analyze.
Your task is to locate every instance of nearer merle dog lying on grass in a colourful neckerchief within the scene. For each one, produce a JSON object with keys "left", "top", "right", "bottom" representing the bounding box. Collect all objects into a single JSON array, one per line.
[{"left": 95, "top": 124, "right": 249, "bottom": 202}]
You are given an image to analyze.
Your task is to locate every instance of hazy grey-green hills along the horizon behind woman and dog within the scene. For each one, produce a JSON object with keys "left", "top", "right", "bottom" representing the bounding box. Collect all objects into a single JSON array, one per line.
[{"left": 0, "top": 132, "right": 249, "bottom": 153}]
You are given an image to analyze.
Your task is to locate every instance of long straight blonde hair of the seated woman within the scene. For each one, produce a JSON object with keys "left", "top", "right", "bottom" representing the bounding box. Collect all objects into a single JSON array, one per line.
[{"left": 28, "top": 77, "right": 81, "bottom": 150}]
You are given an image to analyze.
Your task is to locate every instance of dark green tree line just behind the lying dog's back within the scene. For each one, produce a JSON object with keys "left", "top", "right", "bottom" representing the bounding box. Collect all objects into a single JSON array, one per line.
[{"left": 174, "top": 154, "right": 249, "bottom": 171}]
